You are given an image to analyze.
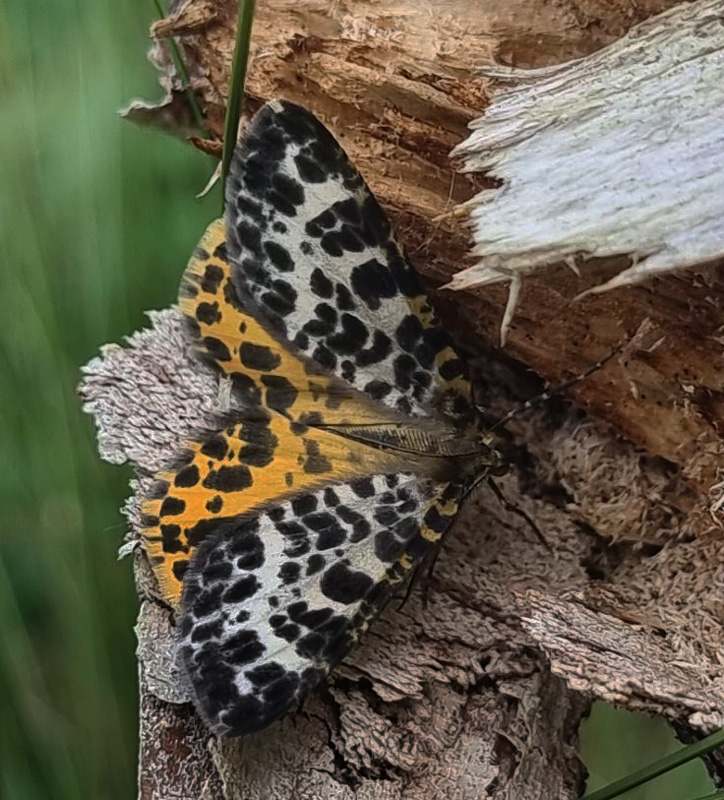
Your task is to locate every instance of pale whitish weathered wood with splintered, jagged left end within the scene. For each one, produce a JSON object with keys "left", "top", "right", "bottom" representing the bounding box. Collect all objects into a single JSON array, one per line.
[{"left": 451, "top": 0, "right": 724, "bottom": 300}]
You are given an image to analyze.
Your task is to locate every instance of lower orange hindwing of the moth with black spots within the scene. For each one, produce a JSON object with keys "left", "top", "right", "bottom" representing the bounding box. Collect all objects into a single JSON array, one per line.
[{"left": 143, "top": 408, "right": 422, "bottom": 606}]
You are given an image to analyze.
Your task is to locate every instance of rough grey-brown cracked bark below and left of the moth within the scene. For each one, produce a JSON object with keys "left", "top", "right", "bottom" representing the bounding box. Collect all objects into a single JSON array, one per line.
[{"left": 82, "top": 311, "right": 724, "bottom": 800}]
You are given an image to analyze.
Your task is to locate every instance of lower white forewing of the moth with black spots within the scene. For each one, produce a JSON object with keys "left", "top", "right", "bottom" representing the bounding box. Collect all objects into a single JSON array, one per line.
[{"left": 180, "top": 475, "right": 444, "bottom": 736}]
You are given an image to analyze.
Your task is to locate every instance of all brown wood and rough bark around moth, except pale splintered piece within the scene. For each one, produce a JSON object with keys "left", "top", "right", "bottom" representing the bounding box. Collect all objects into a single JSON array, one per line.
[{"left": 87, "top": 0, "right": 724, "bottom": 800}]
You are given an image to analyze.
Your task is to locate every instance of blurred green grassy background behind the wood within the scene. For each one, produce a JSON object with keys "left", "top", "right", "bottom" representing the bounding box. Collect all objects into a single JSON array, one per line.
[{"left": 0, "top": 0, "right": 708, "bottom": 800}]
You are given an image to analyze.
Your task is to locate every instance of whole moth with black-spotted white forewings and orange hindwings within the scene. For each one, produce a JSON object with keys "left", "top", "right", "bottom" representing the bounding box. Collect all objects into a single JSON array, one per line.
[{"left": 143, "top": 101, "right": 505, "bottom": 736}]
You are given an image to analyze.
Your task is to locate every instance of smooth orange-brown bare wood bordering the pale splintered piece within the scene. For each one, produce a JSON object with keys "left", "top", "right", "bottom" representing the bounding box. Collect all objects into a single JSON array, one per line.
[{"left": 127, "top": 0, "right": 724, "bottom": 500}]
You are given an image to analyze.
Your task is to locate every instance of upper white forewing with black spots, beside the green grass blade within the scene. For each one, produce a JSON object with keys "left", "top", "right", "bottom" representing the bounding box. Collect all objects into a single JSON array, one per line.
[{"left": 226, "top": 101, "right": 472, "bottom": 427}]
